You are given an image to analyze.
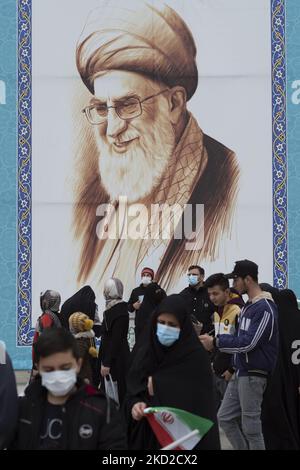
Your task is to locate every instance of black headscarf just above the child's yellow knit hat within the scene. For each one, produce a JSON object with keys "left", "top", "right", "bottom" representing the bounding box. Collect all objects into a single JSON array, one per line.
[{"left": 60, "top": 286, "right": 96, "bottom": 329}]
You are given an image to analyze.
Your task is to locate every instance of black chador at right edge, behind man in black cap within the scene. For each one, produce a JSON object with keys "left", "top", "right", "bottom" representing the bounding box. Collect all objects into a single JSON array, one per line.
[{"left": 262, "top": 289, "right": 300, "bottom": 450}]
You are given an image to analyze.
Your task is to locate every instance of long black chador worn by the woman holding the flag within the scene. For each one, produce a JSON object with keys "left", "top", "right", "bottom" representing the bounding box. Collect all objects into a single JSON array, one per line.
[{"left": 127, "top": 295, "right": 219, "bottom": 449}]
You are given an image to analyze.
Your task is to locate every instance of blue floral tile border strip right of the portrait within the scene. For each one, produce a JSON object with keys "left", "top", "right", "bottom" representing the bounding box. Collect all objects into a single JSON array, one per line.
[{"left": 271, "top": 0, "right": 288, "bottom": 289}]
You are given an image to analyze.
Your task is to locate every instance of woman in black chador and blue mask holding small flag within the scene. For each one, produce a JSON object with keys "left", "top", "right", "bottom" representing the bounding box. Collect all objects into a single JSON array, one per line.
[{"left": 125, "top": 295, "right": 220, "bottom": 450}]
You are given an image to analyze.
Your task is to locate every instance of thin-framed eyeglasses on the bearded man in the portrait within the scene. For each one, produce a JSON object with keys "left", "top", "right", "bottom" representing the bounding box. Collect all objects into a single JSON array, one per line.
[{"left": 82, "top": 88, "right": 169, "bottom": 125}]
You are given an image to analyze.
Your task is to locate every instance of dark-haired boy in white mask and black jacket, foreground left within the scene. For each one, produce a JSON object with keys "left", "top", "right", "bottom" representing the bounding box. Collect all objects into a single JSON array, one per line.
[{"left": 10, "top": 328, "right": 127, "bottom": 450}]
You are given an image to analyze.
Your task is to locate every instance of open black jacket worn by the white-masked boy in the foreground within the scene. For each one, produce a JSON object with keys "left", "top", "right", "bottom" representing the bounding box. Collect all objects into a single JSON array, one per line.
[{"left": 9, "top": 378, "right": 127, "bottom": 450}]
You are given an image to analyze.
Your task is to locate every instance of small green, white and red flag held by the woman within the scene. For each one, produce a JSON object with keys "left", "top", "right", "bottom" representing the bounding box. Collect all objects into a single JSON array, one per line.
[{"left": 144, "top": 407, "right": 213, "bottom": 450}]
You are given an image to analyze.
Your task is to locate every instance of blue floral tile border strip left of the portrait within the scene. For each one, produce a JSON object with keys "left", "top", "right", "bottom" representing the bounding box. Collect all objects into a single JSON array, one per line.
[{"left": 17, "top": 0, "right": 33, "bottom": 346}]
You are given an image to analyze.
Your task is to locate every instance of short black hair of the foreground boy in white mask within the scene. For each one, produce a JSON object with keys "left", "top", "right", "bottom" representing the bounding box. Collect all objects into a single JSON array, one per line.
[{"left": 34, "top": 328, "right": 80, "bottom": 363}]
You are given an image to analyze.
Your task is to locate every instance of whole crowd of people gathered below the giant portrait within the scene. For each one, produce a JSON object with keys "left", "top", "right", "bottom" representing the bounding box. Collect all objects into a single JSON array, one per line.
[{"left": 0, "top": 260, "right": 300, "bottom": 450}]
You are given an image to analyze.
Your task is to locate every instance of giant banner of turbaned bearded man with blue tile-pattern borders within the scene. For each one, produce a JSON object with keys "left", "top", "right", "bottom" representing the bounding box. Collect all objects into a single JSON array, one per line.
[{"left": 0, "top": 0, "right": 300, "bottom": 368}]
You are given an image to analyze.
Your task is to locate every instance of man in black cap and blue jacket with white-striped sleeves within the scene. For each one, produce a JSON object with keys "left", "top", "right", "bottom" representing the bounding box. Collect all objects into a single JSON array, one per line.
[{"left": 200, "top": 260, "right": 278, "bottom": 450}]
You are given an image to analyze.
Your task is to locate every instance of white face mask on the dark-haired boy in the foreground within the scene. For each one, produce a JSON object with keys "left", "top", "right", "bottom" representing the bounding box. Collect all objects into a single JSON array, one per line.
[{"left": 40, "top": 369, "right": 77, "bottom": 397}]
